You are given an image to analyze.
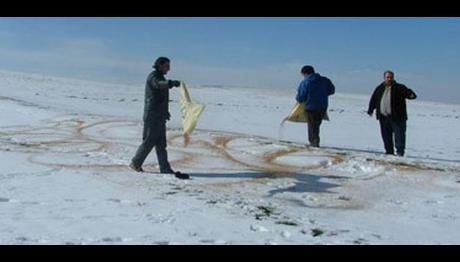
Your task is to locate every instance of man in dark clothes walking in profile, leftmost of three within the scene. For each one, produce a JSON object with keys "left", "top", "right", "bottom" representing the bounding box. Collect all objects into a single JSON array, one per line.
[{"left": 129, "top": 57, "right": 189, "bottom": 179}]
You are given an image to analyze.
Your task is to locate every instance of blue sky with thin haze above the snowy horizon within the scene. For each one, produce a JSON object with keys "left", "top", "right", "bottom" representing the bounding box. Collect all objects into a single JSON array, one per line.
[{"left": 0, "top": 17, "right": 460, "bottom": 103}]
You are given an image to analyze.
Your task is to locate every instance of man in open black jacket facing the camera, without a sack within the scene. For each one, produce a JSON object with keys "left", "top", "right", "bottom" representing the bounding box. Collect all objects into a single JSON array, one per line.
[{"left": 367, "top": 71, "right": 417, "bottom": 156}]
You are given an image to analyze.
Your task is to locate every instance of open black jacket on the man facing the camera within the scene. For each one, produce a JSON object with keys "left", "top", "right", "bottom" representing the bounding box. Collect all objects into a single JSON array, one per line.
[{"left": 367, "top": 81, "right": 417, "bottom": 121}]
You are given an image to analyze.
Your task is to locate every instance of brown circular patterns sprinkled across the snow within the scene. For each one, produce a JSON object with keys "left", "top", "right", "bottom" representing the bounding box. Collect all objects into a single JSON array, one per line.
[{"left": 0, "top": 113, "right": 448, "bottom": 180}]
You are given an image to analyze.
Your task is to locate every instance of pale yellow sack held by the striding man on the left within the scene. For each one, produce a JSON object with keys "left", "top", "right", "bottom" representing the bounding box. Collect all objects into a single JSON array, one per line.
[{"left": 180, "top": 81, "right": 204, "bottom": 146}]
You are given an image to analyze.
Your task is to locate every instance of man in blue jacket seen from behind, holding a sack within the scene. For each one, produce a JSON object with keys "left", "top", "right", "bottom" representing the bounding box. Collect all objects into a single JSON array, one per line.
[{"left": 296, "top": 65, "right": 335, "bottom": 147}]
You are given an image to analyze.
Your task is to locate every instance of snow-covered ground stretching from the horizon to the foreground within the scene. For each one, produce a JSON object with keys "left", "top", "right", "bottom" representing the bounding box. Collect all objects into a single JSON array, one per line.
[{"left": 0, "top": 71, "right": 460, "bottom": 244}]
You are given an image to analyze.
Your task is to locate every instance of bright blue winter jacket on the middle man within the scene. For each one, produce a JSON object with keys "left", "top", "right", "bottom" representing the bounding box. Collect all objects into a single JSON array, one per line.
[{"left": 296, "top": 73, "right": 335, "bottom": 111}]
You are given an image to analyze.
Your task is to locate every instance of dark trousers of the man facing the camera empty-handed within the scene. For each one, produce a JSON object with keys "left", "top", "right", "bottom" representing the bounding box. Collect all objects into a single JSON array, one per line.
[{"left": 379, "top": 116, "right": 406, "bottom": 156}]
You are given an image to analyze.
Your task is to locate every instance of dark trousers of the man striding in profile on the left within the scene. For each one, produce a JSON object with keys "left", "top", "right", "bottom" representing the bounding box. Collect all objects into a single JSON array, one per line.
[{"left": 132, "top": 120, "right": 171, "bottom": 172}]
